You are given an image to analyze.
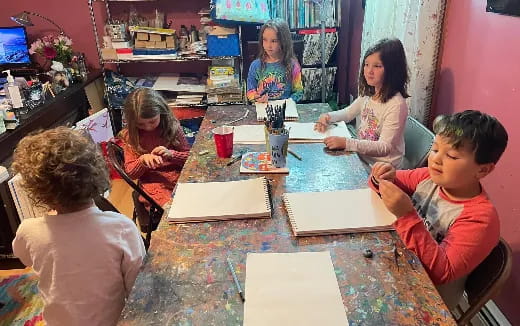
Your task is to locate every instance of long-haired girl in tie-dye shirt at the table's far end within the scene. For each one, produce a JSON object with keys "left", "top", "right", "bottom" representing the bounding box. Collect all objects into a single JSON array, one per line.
[{"left": 247, "top": 19, "right": 303, "bottom": 102}]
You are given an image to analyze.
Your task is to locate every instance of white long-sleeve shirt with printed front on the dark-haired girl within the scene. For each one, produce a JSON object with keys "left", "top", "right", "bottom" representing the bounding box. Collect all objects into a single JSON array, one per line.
[{"left": 329, "top": 93, "right": 408, "bottom": 168}]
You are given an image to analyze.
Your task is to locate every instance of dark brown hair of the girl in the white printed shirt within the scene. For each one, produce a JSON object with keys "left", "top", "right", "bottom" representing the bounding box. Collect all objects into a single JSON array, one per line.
[{"left": 358, "top": 38, "right": 410, "bottom": 103}]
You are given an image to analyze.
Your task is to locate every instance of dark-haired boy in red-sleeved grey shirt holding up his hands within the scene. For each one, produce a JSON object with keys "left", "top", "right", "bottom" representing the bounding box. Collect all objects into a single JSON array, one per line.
[{"left": 370, "top": 110, "right": 508, "bottom": 308}]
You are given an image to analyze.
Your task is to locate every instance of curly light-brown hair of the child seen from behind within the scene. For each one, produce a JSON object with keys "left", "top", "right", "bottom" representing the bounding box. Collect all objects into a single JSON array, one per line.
[{"left": 13, "top": 127, "right": 110, "bottom": 209}]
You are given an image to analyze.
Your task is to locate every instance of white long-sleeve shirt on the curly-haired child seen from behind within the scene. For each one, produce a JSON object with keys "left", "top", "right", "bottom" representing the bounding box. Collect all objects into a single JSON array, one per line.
[{"left": 13, "top": 206, "right": 146, "bottom": 326}]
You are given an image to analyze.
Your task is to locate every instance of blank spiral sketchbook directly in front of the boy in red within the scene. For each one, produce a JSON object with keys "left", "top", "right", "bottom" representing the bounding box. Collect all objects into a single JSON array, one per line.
[{"left": 283, "top": 188, "right": 396, "bottom": 236}]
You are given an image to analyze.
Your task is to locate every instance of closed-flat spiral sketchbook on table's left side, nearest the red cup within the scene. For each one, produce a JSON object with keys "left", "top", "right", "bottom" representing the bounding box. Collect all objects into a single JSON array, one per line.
[{"left": 168, "top": 177, "right": 271, "bottom": 223}]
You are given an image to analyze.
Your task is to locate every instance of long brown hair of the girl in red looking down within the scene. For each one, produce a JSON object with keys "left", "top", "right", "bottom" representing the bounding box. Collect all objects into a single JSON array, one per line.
[{"left": 121, "top": 88, "right": 181, "bottom": 154}]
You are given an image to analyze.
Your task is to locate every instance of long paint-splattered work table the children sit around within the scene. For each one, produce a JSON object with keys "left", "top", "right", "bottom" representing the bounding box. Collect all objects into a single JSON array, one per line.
[{"left": 119, "top": 104, "right": 455, "bottom": 325}]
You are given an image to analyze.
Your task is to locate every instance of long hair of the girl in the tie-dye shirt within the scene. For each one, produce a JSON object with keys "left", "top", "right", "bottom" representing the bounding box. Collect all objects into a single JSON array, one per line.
[{"left": 258, "top": 18, "right": 296, "bottom": 79}]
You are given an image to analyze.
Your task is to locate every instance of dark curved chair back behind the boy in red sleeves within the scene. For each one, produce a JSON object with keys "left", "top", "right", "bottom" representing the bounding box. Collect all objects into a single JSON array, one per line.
[{"left": 456, "top": 238, "right": 513, "bottom": 326}]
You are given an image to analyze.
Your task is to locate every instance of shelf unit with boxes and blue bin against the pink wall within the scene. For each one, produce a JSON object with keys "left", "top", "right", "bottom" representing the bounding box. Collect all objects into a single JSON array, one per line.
[{"left": 88, "top": 0, "right": 245, "bottom": 131}]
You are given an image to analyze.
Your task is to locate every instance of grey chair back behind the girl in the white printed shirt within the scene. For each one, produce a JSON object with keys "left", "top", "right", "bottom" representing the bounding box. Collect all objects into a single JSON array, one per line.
[{"left": 403, "top": 116, "right": 435, "bottom": 169}]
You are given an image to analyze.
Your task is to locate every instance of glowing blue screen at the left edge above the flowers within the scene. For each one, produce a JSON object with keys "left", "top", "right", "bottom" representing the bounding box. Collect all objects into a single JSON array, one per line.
[{"left": 0, "top": 26, "right": 31, "bottom": 66}]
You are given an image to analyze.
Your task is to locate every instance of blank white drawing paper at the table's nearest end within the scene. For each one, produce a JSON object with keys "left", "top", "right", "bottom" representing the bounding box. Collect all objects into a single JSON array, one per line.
[{"left": 243, "top": 251, "right": 349, "bottom": 326}]
